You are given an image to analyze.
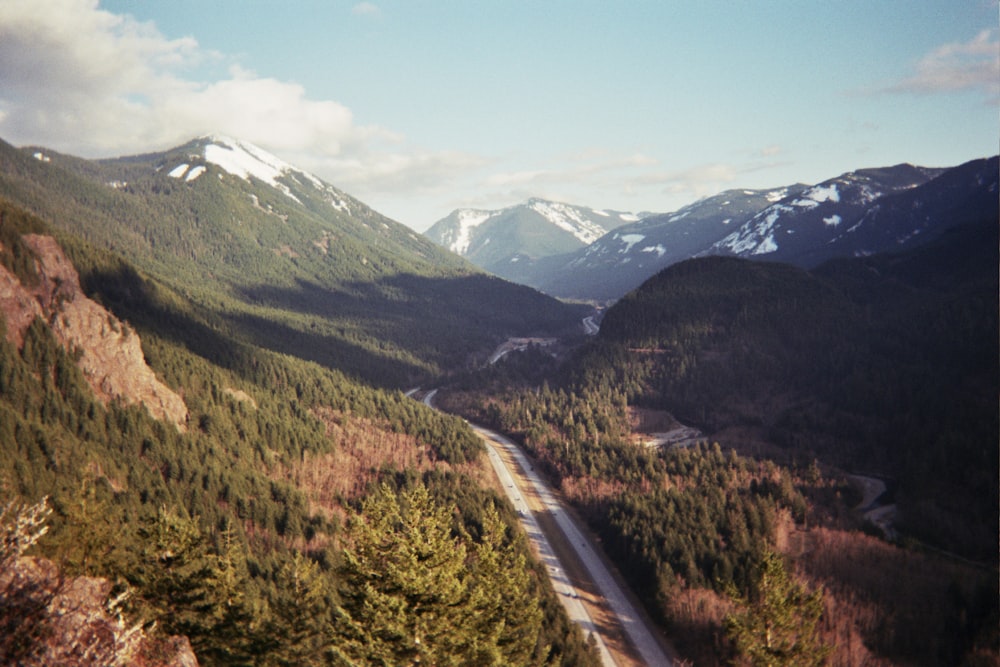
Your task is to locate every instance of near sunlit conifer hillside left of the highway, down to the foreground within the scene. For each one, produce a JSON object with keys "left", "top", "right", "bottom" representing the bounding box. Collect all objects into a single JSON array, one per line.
[{"left": 0, "top": 201, "right": 596, "bottom": 666}]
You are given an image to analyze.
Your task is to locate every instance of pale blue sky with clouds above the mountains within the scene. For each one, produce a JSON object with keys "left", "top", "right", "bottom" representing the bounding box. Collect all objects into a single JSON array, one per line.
[{"left": 0, "top": 0, "right": 1000, "bottom": 231}]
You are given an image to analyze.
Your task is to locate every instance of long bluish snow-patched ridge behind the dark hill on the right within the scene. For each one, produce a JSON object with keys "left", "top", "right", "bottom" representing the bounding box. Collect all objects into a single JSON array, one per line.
[{"left": 488, "top": 158, "right": 997, "bottom": 300}]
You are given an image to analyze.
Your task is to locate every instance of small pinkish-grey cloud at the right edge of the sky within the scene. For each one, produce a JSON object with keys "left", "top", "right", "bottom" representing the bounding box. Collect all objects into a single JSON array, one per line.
[{"left": 886, "top": 29, "right": 1000, "bottom": 102}]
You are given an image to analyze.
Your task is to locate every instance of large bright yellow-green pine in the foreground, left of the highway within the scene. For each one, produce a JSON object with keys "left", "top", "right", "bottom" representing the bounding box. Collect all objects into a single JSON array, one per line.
[{"left": 338, "top": 486, "right": 480, "bottom": 665}]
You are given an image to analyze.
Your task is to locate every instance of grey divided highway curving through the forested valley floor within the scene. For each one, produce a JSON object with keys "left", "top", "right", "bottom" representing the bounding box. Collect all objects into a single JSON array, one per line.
[{"left": 423, "top": 389, "right": 673, "bottom": 666}]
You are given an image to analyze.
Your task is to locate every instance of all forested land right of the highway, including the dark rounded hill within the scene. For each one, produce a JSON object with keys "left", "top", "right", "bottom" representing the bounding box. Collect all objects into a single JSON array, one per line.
[{"left": 440, "top": 213, "right": 1000, "bottom": 665}]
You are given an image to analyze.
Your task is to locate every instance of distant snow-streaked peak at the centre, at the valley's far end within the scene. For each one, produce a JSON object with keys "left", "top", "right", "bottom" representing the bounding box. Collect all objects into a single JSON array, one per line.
[{"left": 424, "top": 199, "right": 638, "bottom": 282}]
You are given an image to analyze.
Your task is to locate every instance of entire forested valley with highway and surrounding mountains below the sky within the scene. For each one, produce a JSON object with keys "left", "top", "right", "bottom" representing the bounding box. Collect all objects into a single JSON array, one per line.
[{"left": 0, "top": 136, "right": 1000, "bottom": 667}]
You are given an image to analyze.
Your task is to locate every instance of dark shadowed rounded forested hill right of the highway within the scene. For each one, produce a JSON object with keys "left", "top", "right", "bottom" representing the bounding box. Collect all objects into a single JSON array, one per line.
[{"left": 580, "top": 220, "right": 1000, "bottom": 560}]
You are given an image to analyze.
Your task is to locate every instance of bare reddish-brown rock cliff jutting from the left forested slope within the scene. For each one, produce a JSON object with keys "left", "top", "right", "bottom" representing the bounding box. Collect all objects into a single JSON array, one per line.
[{"left": 0, "top": 234, "right": 187, "bottom": 428}]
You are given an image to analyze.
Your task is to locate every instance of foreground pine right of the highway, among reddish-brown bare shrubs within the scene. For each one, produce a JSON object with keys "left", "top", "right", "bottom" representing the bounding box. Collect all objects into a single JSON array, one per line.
[{"left": 726, "top": 551, "right": 830, "bottom": 667}]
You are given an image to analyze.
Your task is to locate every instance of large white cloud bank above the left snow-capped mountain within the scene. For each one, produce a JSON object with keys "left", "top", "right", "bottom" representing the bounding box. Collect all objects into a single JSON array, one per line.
[{"left": 0, "top": 0, "right": 474, "bottom": 198}]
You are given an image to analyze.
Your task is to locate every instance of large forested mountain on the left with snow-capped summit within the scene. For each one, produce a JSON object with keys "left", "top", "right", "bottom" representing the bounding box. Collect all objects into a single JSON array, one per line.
[{"left": 0, "top": 137, "right": 579, "bottom": 386}]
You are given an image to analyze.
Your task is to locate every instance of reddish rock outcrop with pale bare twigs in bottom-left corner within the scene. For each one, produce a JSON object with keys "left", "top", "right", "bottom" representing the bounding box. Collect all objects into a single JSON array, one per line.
[{"left": 0, "top": 557, "right": 198, "bottom": 667}]
